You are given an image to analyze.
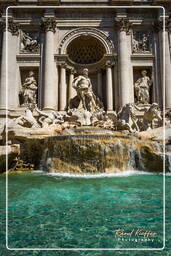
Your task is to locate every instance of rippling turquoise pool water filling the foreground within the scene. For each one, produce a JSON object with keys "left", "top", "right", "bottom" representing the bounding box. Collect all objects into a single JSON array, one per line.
[{"left": 0, "top": 173, "right": 171, "bottom": 255}]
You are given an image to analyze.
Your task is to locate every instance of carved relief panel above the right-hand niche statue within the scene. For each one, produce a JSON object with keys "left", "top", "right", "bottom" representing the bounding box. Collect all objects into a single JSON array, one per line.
[{"left": 132, "top": 31, "right": 150, "bottom": 53}]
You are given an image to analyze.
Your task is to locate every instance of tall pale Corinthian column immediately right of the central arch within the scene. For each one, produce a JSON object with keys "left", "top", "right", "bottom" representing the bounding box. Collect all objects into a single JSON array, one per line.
[{"left": 116, "top": 18, "right": 134, "bottom": 107}]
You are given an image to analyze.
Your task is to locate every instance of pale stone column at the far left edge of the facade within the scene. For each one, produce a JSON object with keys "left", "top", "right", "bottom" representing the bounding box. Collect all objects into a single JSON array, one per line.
[{"left": 0, "top": 19, "right": 19, "bottom": 109}]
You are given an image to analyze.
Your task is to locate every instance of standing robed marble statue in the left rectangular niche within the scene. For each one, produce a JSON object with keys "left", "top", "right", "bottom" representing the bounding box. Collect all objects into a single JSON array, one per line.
[{"left": 21, "top": 71, "right": 37, "bottom": 106}]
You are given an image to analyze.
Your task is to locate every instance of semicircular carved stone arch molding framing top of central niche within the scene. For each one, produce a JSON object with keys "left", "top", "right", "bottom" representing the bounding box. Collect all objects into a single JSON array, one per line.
[{"left": 59, "top": 27, "right": 114, "bottom": 54}]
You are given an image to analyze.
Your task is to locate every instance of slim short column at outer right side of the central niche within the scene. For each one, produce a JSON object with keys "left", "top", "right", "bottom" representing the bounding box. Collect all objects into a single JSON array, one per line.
[{"left": 106, "top": 61, "right": 113, "bottom": 111}]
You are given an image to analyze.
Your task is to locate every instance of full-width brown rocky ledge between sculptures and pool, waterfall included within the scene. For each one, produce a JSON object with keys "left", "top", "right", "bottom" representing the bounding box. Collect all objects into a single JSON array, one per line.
[{"left": 1, "top": 126, "right": 171, "bottom": 173}]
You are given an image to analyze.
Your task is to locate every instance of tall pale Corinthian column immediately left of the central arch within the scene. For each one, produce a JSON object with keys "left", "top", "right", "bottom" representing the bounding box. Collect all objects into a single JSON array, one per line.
[{"left": 42, "top": 18, "right": 57, "bottom": 109}]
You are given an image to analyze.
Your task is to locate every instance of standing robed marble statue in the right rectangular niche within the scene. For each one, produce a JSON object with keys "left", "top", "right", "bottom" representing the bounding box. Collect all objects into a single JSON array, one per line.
[{"left": 134, "top": 70, "right": 152, "bottom": 104}]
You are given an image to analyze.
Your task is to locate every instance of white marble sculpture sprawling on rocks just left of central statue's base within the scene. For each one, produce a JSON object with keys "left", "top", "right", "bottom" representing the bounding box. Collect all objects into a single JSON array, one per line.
[{"left": 35, "top": 107, "right": 64, "bottom": 128}]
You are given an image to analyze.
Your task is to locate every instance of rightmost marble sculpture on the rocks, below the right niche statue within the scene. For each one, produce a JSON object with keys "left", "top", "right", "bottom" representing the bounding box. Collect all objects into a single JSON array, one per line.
[{"left": 143, "top": 103, "right": 163, "bottom": 130}]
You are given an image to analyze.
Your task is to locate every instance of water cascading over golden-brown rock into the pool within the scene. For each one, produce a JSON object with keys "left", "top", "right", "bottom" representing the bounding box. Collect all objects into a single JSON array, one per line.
[{"left": 41, "top": 127, "right": 168, "bottom": 174}]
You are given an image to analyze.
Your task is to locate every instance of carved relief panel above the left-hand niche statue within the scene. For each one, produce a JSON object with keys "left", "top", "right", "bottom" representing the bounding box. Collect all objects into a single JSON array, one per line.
[{"left": 21, "top": 31, "right": 40, "bottom": 52}]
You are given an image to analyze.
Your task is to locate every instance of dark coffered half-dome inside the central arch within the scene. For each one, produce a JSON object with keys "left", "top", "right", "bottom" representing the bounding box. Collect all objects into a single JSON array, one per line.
[{"left": 67, "top": 35, "right": 106, "bottom": 65}]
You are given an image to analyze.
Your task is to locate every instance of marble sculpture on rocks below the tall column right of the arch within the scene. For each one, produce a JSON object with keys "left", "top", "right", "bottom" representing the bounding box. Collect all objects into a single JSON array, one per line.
[{"left": 117, "top": 103, "right": 139, "bottom": 132}]
